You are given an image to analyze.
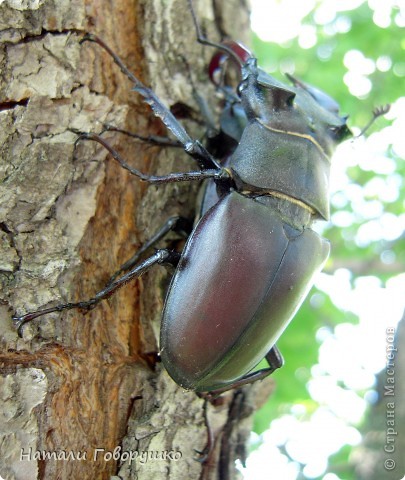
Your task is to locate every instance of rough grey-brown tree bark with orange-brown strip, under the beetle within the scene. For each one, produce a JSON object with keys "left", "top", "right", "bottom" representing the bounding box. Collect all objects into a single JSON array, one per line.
[{"left": 0, "top": 0, "right": 271, "bottom": 480}]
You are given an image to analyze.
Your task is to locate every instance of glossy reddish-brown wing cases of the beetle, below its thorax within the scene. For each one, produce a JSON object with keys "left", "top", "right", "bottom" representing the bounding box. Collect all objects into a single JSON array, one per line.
[{"left": 161, "top": 192, "right": 329, "bottom": 391}]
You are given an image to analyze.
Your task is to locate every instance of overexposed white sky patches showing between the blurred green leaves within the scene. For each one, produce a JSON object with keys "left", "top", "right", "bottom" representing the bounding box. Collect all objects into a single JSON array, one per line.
[{"left": 240, "top": 0, "right": 405, "bottom": 480}]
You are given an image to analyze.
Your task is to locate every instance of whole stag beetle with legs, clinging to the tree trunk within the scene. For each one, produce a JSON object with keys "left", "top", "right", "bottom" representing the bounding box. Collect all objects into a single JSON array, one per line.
[{"left": 14, "top": 1, "right": 350, "bottom": 393}]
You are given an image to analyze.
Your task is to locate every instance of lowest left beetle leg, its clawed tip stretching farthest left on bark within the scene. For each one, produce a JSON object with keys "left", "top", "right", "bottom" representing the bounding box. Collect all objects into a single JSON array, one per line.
[{"left": 13, "top": 249, "right": 180, "bottom": 337}]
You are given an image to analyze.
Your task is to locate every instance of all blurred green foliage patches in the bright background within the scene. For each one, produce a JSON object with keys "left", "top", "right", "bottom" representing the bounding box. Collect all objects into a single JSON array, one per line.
[{"left": 252, "top": 2, "right": 405, "bottom": 480}]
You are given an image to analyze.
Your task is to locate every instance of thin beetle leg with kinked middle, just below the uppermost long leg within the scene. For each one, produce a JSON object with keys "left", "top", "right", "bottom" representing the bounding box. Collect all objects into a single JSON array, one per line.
[{"left": 72, "top": 130, "right": 230, "bottom": 185}]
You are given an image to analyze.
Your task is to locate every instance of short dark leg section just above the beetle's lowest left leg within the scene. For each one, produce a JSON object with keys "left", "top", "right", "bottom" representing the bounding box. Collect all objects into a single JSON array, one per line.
[{"left": 108, "top": 216, "right": 192, "bottom": 285}]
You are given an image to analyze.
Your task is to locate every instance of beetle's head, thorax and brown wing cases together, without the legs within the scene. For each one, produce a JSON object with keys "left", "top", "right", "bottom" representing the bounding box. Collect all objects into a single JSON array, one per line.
[{"left": 161, "top": 54, "right": 348, "bottom": 392}]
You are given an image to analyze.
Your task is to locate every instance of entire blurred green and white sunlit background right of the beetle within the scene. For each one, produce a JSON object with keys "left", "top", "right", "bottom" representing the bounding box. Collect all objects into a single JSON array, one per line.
[{"left": 239, "top": 0, "right": 405, "bottom": 480}]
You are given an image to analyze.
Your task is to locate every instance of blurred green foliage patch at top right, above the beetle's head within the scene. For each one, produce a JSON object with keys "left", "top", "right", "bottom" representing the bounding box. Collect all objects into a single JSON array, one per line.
[{"left": 252, "top": 3, "right": 405, "bottom": 126}]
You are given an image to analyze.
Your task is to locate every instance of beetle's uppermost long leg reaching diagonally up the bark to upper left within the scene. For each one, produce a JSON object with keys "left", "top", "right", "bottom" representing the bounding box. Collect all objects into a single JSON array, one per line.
[{"left": 80, "top": 34, "right": 220, "bottom": 169}]
